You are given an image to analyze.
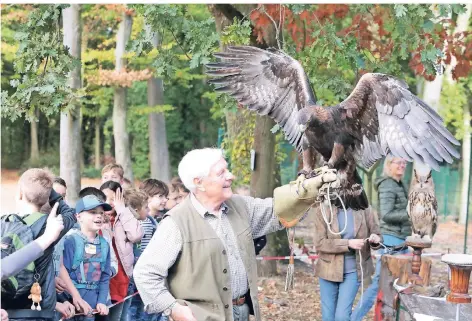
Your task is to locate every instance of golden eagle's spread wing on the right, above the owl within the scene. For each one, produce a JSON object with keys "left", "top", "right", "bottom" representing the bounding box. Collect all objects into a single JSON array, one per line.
[{"left": 333, "top": 74, "right": 460, "bottom": 170}]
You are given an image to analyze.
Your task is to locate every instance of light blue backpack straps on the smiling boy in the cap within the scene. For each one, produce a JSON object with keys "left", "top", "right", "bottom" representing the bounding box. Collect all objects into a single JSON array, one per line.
[{"left": 69, "top": 233, "right": 110, "bottom": 289}]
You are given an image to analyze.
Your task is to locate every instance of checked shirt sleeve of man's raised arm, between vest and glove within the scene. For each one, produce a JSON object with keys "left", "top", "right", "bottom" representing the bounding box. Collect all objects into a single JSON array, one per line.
[{"left": 234, "top": 195, "right": 284, "bottom": 239}]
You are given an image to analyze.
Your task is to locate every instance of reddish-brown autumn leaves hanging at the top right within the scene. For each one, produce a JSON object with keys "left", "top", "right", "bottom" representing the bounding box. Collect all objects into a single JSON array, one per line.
[{"left": 250, "top": 4, "right": 472, "bottom": 80}]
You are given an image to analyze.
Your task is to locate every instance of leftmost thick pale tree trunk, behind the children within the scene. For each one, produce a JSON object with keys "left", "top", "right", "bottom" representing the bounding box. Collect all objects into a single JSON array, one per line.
[{"left": 60, "top": 4, "right": 82, "bottom": 205}]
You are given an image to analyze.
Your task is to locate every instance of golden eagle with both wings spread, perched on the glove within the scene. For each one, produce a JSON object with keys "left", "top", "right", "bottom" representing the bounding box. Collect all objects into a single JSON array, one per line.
[{"left": 207, "top": 46, "right": 460, "bottom": 210}]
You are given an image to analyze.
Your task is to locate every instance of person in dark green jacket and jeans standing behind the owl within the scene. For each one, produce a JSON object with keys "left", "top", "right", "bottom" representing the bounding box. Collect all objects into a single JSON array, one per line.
[{"left": 351, "top": 156, "right": 411, "bottom": 321}]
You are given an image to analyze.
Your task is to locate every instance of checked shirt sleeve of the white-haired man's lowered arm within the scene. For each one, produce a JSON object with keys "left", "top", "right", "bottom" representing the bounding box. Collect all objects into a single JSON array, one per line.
[{"left": 133, "top": 217, "right": 182, "bottom": 313}]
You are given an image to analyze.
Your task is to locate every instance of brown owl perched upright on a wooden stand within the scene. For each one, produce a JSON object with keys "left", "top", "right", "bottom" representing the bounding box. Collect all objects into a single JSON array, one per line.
[{"left": 407, "top": 170, "right": 438, "bottom": 242}]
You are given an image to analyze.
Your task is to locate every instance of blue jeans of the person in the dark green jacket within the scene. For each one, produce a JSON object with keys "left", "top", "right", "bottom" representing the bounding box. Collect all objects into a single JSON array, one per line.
[{"left": 351, "top": 234, "right": 408, "bottom": 321}]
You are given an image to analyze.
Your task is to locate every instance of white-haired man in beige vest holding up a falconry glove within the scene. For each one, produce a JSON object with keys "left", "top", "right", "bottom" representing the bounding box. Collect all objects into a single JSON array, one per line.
[{"left": 134, "top": 148, "right": 336, "bottom": 321}]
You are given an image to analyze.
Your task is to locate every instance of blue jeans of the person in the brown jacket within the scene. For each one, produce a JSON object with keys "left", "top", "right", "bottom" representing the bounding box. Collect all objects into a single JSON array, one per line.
[{"left": 319, "top": 272, "right": 360, "bottom": 321}]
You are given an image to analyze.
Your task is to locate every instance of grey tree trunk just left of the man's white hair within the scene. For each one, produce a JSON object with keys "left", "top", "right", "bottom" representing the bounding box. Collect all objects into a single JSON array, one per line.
[{"left": 147, "top": 28, "right": 171, "bottom": 182}]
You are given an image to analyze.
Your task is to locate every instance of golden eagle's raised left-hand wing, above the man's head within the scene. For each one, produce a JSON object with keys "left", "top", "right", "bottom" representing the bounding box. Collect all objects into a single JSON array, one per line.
[{"left": 206, "top": 46, "right": 316, "bottom": 151}]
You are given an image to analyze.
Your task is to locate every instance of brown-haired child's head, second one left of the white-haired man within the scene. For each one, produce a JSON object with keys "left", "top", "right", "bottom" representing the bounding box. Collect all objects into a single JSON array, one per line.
[{"left": 139, "top": 178, "right": 169, "bottom": 221}]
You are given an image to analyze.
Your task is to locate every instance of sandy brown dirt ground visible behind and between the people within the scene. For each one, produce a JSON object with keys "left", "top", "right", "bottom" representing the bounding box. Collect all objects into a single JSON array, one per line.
[{"left": 0, "top": 170, "right": 472, "bottom": 321}]
